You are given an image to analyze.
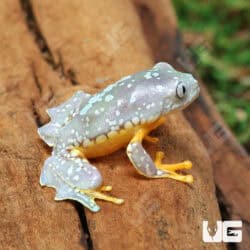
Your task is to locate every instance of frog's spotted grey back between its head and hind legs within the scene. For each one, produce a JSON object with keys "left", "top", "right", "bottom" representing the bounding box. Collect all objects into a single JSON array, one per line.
[{"left": 80, "top": 71, "right": 165, "bottom": 143}]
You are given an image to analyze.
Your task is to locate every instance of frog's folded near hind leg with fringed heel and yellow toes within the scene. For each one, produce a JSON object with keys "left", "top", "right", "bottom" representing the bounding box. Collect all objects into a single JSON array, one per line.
[{"left": 40, "top": 151, "right": 123, "bottom": 212}]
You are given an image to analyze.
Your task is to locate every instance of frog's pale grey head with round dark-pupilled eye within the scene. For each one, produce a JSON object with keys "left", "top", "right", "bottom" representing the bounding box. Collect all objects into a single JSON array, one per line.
[{"left": 153, "top": 62, "right": 200, "bottom": 113}]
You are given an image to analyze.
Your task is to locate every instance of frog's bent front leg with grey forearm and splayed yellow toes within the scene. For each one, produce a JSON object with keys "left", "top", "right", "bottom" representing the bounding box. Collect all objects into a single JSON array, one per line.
[{"left": 127, "top": 128, "right": 193, "bottom": 183}]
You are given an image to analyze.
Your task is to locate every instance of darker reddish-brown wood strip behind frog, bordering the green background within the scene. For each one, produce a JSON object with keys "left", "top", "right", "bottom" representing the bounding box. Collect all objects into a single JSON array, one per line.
[{"left": 134, "top": 0, "right": 250, "bottom": 249}]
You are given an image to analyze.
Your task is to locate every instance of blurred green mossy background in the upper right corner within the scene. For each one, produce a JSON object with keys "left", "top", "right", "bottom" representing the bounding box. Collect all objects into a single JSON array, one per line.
[{"left": 173, "top": 0, "right": 250, "bottom": 152}]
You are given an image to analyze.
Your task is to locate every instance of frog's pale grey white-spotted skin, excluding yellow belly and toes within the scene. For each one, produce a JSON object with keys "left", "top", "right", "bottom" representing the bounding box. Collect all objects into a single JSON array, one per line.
[{"left": 38, "top": 63, "right": 199, "bottom": 211}]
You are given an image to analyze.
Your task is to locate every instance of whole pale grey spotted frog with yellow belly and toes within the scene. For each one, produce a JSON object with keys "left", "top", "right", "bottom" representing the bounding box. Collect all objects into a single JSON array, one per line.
[{"left": 38, "top": 62, "right": 200, "bottom": 212}]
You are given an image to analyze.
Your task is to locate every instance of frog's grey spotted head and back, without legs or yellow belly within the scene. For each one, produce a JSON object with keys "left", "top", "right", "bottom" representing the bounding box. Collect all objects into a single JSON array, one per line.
[{"left": 63, "top": 63, "right": 199, "bottom": 146}]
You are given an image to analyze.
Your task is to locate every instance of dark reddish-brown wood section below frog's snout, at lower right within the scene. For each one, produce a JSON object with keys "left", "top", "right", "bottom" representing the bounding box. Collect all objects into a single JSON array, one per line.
[{"left": 185, "top": 88, "right": 250, "bottom": 250}]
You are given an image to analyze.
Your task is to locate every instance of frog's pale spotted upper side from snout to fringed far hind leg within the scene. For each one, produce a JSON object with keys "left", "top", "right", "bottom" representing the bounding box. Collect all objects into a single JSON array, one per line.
[{"left": 38, "top": 59, "right": 199, "bottom": 170}]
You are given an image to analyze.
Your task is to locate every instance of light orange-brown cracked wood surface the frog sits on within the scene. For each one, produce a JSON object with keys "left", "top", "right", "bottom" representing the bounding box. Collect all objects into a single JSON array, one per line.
[{"left": 0, "top": 0, "right": 228, "bottom": 250}]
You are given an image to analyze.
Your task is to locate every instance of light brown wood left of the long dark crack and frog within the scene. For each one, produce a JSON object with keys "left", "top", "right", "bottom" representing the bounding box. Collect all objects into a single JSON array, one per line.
[{"left": 0, "top": 0, "right": 87, "bottom": 249}]
